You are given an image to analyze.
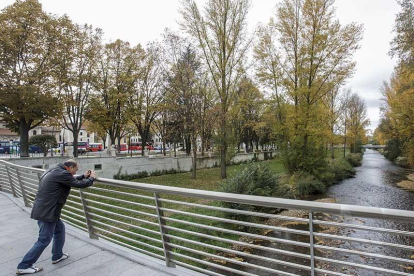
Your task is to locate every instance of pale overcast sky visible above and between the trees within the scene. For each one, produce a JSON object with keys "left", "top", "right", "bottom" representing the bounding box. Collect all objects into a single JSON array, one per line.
[{"left": 0, "top": 0, "right": 400, "bottom": 130}]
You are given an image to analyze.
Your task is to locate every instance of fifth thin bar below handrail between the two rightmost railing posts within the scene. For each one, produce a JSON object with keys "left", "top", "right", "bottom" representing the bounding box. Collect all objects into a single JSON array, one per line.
[{"left": 165, "top": 234, "right": 311, "bottom": 270}]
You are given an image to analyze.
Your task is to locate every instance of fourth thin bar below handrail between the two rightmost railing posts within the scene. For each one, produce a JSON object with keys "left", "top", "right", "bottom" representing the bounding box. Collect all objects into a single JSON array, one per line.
[{"left": 163, "top": 225, "right": 310, "bottom": 260}]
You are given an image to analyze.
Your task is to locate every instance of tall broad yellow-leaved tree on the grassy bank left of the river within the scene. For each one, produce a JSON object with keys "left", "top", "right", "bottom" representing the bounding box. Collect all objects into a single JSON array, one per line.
[{"left": 256, "top": 0, "right": 362, "bottom": 172}]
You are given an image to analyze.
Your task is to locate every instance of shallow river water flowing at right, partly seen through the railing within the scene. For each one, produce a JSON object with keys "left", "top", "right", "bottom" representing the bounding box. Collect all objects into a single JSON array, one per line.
[{"left": 217, "top": 150, "right": 414, "bottom": 276}]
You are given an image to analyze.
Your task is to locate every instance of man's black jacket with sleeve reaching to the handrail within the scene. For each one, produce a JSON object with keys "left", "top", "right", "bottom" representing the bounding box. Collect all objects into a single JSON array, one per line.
[{"left": 30, "top": 164, "right": 94, "bottom": 222}]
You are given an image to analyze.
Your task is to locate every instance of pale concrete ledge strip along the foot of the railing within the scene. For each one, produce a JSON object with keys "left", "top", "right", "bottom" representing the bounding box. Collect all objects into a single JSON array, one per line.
[{"left": 0, "top": 192, "right": 206, "bottom": 276}]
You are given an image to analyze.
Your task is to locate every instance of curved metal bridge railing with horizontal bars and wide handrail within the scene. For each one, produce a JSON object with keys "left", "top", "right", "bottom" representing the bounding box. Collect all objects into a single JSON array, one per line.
[{"left": 0, "top": 161, "right": 414, "bottom": 276}]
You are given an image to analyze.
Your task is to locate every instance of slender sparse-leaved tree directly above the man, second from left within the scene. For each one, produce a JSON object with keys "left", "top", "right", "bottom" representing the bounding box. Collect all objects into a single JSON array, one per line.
[{"left": 56, "top": 18, "right": 102, "bottom": 157}]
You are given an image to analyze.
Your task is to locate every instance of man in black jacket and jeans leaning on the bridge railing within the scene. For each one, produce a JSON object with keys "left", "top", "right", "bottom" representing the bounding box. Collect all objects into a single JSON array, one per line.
[{"left": 16, "top": 159, "right": 96, "bottom": 275}]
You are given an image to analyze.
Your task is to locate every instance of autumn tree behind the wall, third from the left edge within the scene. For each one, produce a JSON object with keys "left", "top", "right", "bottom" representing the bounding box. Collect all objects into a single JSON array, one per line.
[{"left": 87, "top": 39, "right": 141, "bottom": 149}]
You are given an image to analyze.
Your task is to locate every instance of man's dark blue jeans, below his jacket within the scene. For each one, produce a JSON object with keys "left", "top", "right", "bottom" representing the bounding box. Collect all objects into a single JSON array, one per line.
[{"left": 17, "top": 219, "right": 65, "bottom": 269}]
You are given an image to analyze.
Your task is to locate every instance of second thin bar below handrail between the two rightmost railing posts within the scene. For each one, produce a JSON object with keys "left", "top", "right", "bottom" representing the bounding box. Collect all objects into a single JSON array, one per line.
[{"left": 160, "top": 208, "right": 309, "bottom": 236}]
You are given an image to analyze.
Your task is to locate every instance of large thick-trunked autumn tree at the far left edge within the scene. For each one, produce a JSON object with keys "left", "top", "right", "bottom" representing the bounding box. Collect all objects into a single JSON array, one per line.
[{"left": 0, "top": 0, "right": 60, "bottom": 157}]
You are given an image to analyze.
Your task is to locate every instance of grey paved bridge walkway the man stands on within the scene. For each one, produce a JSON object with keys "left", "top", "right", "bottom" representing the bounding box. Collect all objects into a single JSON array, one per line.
[{"left": 0, "top": 192, "right": 201, "bottom": 276}]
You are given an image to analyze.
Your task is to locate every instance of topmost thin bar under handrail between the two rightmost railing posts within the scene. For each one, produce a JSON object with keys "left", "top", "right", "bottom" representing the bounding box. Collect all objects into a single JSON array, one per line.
[{"left": 159, "top": 198, "right": 309, "bottom": 223}]
